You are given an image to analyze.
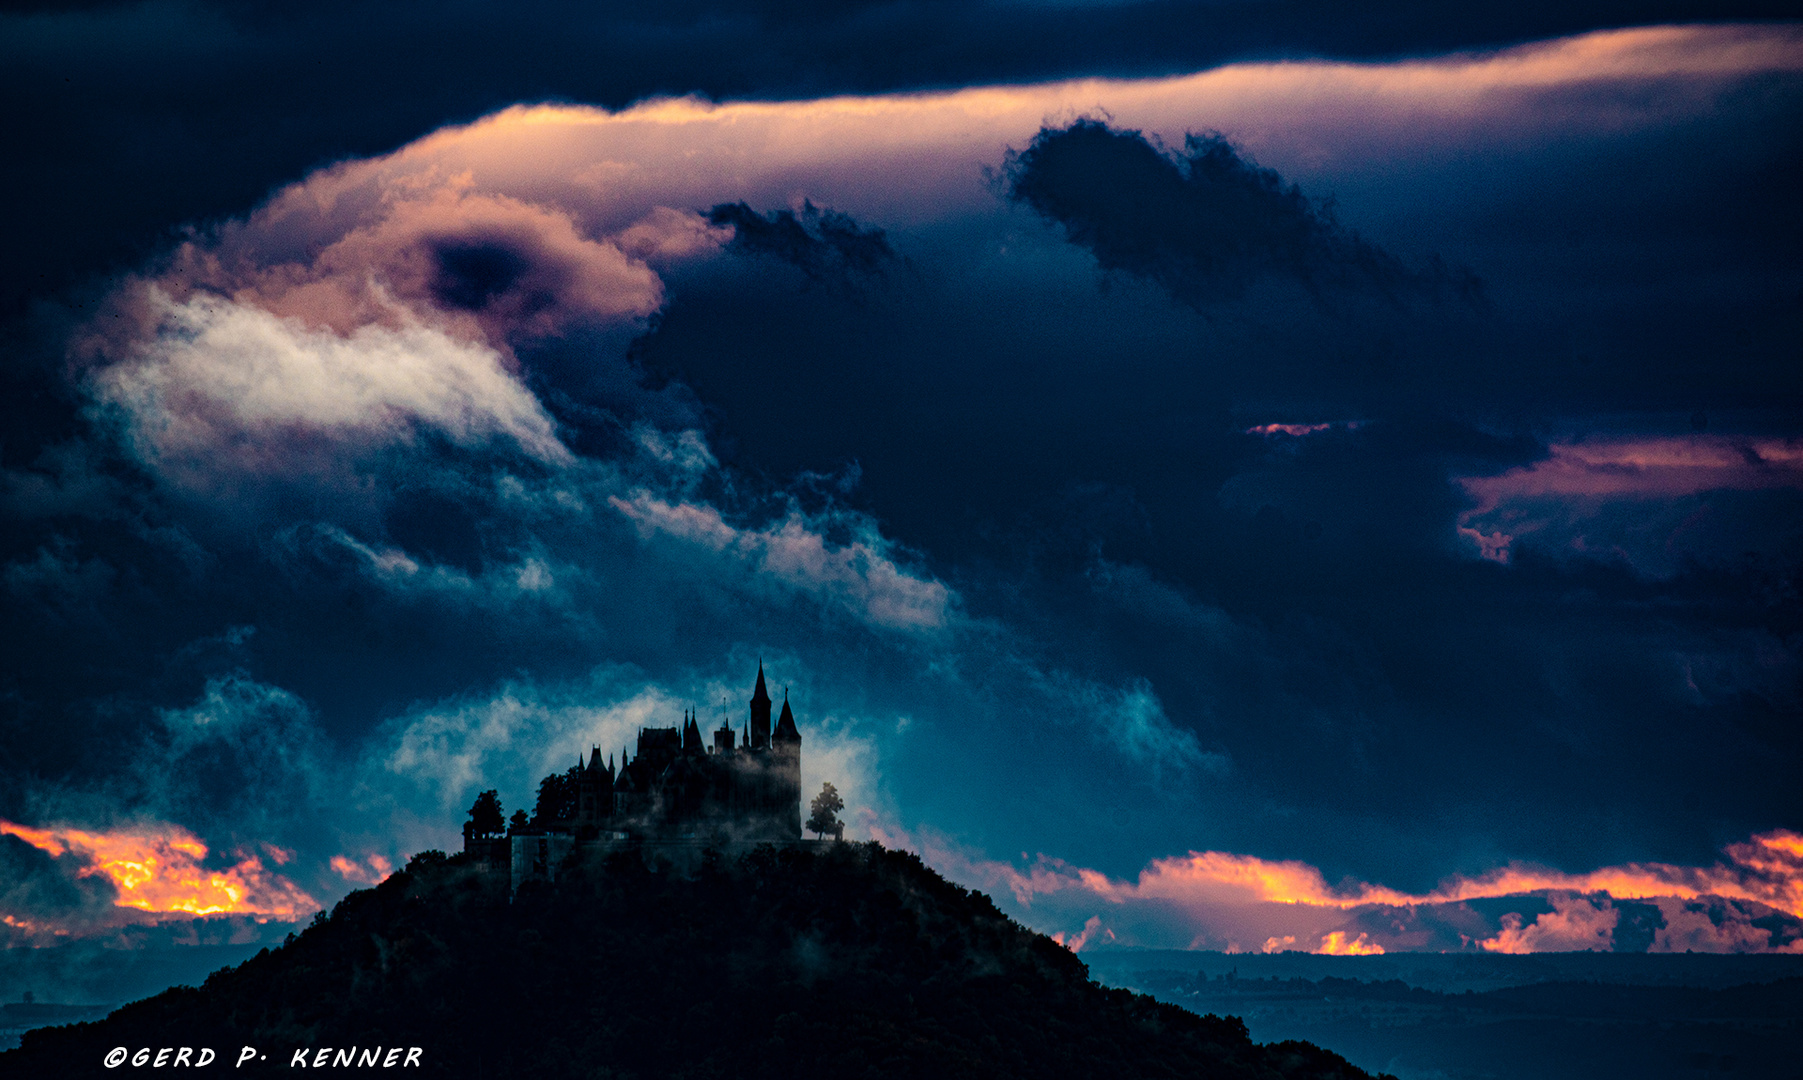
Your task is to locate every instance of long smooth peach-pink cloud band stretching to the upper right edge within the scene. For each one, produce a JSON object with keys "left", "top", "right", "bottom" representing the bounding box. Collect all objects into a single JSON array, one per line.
[{"left": 232, "top": 25, "right": 1803, "bottom": 249}]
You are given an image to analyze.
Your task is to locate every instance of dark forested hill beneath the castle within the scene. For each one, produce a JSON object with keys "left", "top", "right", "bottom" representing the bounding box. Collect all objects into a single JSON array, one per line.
[{"left": 0, "top": 844, "right": 1391, "bottom": 1080}]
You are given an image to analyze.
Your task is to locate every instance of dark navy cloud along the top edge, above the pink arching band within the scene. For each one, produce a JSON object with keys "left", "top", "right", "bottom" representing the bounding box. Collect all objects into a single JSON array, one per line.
[{"left": 0, "top": 0, "right": 1798, "bottom": 314}]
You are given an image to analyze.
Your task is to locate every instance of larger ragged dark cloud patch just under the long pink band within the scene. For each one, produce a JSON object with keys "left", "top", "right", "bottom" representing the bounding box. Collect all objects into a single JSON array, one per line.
[{"left": 1002, "top": 119, "right": 1482, "bottom": 308}]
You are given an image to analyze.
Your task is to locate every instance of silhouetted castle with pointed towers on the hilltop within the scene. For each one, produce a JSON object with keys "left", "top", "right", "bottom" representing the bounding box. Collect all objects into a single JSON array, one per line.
[{"left": 463, "top": 664, "right": 801, "bottom": 887}]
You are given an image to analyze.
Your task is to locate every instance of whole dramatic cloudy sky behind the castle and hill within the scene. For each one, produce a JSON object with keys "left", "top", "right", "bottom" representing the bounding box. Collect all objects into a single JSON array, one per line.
[{"left": 0, "top": 0, "right": 1803, "bottom": 963}]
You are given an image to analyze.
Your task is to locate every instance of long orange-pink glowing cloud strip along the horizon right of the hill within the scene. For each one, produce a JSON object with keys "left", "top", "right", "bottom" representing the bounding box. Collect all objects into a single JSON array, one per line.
[{"left": 869, "top": 824, "right": 1803, "bottom": 956}]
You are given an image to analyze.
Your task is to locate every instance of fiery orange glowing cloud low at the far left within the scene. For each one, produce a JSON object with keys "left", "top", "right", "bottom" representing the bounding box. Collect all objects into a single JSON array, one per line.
[{"left": 0, "top": 820, "right": 319, "bottom": 925}]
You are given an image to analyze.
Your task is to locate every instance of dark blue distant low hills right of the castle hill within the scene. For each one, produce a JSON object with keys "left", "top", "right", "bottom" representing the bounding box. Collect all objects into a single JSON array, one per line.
[{"left": 1091, "top": 954, "right": 1803, "bottom": 1080}]
